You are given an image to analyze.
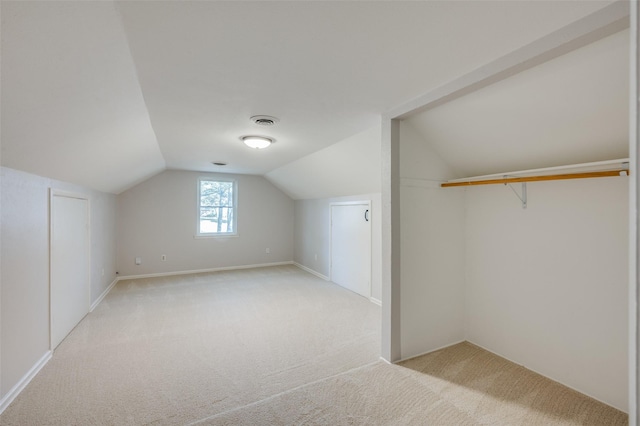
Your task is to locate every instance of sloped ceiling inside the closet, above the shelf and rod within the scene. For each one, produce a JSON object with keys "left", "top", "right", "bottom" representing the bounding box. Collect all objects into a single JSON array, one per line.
[{"left": 407, "top": 30, "right": 629, "bottom": 178}]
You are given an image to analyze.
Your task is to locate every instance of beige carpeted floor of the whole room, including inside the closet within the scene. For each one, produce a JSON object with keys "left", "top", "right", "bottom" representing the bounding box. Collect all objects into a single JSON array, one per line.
[{"left": 0, "top": 266, "right": 627, "bottom": 425}]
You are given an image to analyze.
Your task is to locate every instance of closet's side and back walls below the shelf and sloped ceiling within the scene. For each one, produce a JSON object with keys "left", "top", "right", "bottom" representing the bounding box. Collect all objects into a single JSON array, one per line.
[{"left": 400, "top": 122, "right": 629, "bottom": 411}]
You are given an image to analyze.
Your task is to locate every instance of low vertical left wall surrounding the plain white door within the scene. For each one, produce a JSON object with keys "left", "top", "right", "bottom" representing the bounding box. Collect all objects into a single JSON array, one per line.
[{"left": 0, "top": 167, "right": 116, "bottom": 400}]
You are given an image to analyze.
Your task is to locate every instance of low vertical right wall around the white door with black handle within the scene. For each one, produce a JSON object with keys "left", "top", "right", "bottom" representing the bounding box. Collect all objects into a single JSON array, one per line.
[{"left": 294, "top": 193, "right": 382, "bottom": 301}]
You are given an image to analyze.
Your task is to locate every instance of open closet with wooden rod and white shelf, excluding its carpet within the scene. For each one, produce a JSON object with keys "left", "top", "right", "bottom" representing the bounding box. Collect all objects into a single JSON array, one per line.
[{"left": 383, "top": 1, "right": 636, "bottom": 418}]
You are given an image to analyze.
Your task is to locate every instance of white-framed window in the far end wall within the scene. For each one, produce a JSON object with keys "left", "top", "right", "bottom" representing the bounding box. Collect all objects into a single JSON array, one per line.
[{"left": 198, "top": 178, "right": 238, "bottom": 236}]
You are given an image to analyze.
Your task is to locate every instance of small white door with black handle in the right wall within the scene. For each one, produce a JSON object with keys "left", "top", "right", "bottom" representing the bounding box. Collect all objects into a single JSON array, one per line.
[{"left": 331, "top": 202, "right": 371, "bottom": 298}]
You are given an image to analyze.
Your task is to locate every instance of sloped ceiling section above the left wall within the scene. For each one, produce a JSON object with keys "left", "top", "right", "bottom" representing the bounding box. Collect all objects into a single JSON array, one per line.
[{"left": 1, "top": 2, "right": 165, "bottom": 192}]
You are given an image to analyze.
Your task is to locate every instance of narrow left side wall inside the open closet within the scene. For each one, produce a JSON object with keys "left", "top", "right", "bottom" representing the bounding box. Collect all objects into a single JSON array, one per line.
[{"left": 400, "top": 122, "right": 465, "bottom": 359}]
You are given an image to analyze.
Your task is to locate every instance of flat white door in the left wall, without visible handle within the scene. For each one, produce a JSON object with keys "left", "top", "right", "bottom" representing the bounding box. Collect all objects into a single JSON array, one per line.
[{"left": 50, "top": 193, "right": 91, "bottom": 349}]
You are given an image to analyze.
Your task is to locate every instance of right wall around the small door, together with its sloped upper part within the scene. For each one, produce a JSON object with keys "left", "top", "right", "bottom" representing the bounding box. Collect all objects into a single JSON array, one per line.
[{"left": 276, "top": 125, "right": 382, "bottom": 301}]
